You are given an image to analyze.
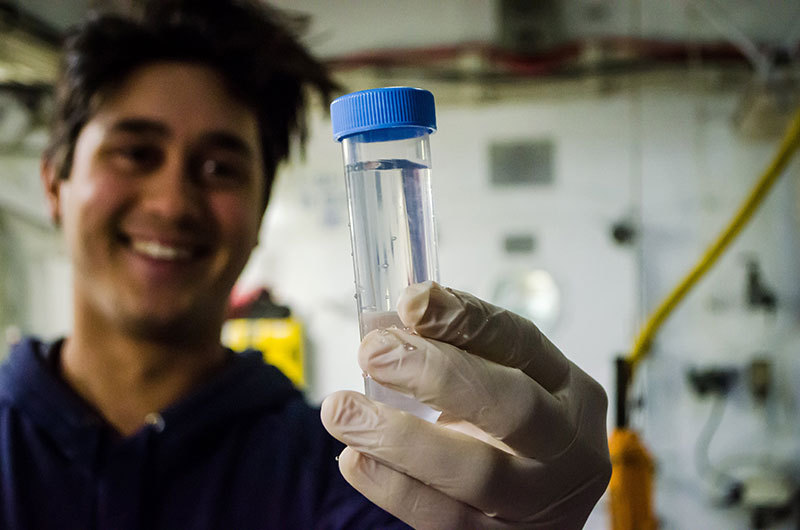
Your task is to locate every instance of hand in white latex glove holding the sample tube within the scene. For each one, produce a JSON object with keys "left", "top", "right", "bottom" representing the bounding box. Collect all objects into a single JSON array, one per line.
[{"left": 322, "top": 282, "right": 611, "bottom": 530}]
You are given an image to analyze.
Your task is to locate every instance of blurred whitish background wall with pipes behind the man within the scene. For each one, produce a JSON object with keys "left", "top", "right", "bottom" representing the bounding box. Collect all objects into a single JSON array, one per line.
[{"left": 0, "top": 0, "right": 800, "bottom": 529}]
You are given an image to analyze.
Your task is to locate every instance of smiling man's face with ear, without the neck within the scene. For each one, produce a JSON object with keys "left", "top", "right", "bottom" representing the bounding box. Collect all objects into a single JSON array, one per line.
[{"left": 44, "top": 62, "right": 264, "bottom": 340}]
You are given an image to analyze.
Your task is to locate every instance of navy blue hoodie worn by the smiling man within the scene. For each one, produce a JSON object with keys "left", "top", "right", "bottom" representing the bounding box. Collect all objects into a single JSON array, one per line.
[{"left": 0, "top": 339, "right": 408, "bottom": 530}]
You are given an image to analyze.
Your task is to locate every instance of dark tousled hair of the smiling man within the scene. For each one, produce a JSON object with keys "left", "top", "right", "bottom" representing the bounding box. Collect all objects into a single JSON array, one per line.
[{"left": 44, "top": 0, "right": 338, "bottom": 205}]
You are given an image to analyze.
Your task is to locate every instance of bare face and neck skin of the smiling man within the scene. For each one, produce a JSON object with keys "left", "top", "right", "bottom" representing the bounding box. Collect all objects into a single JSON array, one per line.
[{"left": 44, "top": 61, "right": 264, "bottom": 435}]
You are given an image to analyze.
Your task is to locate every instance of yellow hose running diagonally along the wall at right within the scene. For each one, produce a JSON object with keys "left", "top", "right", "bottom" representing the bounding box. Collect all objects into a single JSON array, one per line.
[{"left": 628, "top": 110, "right": 800, "bottom": 370}]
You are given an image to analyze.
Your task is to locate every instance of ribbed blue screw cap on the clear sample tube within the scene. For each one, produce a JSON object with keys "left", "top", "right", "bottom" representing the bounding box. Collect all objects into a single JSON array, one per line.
[{"left": 331, "top": 87, "right": 436, "bottom": 142}]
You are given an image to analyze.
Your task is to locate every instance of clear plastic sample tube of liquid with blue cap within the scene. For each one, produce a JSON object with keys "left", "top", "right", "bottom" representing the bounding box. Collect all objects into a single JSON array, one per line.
[{"left": 331, "top": 87, "right": 439, "bottom": 421}]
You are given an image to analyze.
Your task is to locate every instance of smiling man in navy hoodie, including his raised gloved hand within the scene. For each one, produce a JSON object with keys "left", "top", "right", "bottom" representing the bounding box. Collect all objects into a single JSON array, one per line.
[{"left": 0, "top": 0, "right": 610, "bottom": 530}]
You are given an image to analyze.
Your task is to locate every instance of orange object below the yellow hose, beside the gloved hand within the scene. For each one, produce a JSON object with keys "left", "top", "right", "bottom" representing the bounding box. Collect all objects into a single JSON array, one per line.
[{"left": 608, "top": 428, "right": 658, "bottom": 530}]
